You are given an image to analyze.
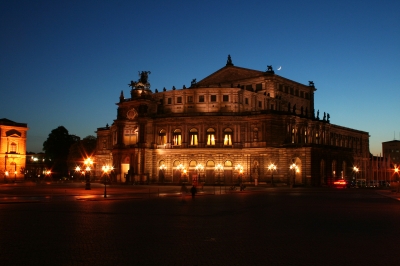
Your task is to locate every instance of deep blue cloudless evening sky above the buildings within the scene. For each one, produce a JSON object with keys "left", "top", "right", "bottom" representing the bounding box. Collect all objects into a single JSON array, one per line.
[{"left": 0, "top": 0, "right": 400, "bottom": 155}]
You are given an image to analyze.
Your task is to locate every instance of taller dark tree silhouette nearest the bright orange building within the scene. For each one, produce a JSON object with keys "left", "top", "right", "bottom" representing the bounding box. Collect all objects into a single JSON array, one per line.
[{"left": 43, "top": 126, "right": 80, "bottom": 178}]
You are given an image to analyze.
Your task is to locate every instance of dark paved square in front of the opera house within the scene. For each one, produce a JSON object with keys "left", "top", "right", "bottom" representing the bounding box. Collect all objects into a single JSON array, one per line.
[{"left": 0, "top": 185, "right": 400, "bottom": 265}]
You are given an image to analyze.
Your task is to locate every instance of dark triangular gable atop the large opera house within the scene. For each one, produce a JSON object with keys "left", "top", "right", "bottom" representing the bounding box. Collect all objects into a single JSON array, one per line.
[{"left": 196, "top": 66, "right": 265, "bottom": 87}]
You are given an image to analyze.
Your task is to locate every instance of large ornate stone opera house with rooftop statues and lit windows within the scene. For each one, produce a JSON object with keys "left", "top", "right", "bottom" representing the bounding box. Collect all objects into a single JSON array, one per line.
[{"left": 96, "top": 57, "right": 369, "bottom": 186}]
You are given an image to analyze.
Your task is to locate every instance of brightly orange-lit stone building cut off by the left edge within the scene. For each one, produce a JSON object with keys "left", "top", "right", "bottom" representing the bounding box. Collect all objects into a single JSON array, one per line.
[{"left": 0, "top": 118, "right": 28, "bottom": 182}]
